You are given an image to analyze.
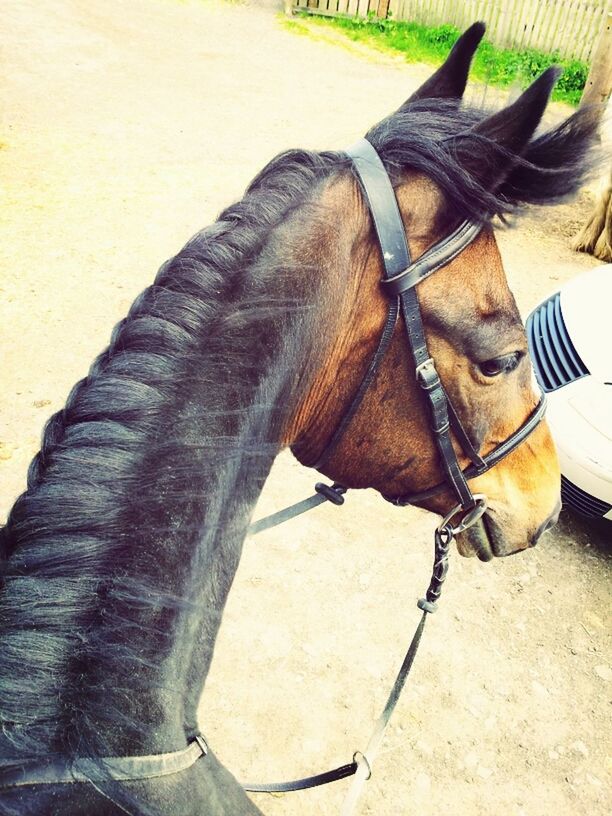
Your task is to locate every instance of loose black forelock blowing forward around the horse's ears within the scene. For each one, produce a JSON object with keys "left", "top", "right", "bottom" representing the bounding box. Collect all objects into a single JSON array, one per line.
[{"left": 366, "top": 99, "right": 597, "bottom": 221}]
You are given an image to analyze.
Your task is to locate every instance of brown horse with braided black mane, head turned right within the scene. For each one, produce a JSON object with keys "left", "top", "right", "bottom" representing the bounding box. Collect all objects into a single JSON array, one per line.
[{"left": 0, "top": 24, "right": 595, "bottom": 816}]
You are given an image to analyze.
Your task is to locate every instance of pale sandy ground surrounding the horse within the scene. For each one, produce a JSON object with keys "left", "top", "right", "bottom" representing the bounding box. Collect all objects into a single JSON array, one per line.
[{"left": 0, "top": 0, "right": 612, "bottom": 816}]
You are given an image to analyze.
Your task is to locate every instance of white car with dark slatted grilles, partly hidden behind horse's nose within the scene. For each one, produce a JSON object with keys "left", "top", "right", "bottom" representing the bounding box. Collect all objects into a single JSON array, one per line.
[{"left": 526, "top": 264, "right": 612, "bottom": 520}]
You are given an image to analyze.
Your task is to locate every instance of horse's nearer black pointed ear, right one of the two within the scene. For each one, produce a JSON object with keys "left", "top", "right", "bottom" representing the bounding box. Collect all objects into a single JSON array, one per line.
[{"left": 455, "top": 67, "right": 561, "bottom": 190}]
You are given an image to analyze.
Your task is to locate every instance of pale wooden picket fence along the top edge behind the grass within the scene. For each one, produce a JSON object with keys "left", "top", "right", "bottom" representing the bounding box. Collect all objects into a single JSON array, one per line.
[{"left": 293, "top": 0, "right": 610, "bottom": 62}]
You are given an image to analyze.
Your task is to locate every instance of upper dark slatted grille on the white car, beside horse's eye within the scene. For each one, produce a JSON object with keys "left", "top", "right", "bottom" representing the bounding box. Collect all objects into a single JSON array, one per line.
[{"left": 525, "top": 292, "right": 589, "bottom": 391}]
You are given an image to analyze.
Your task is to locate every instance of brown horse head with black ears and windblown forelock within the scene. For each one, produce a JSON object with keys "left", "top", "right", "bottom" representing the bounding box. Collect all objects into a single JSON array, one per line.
[{"left": 291, "top": 24, "right": 593, "bottom": 560}]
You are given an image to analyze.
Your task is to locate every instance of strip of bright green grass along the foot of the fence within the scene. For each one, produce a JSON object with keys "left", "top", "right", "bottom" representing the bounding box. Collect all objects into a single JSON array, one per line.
[{"left": 284, "top": 15, "right": 588, "bottom": 105}]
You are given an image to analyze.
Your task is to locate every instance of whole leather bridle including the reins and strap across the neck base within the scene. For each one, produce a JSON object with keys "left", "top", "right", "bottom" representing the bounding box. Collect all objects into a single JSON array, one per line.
[{"left": 0, "top": 139, "right": 546, "bottom": 816}]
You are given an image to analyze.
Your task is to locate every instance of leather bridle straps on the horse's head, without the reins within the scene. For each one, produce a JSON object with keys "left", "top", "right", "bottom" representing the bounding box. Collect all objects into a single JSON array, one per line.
[{"left": 313, "top": 139, "right": 546, "bottom": 533}]
